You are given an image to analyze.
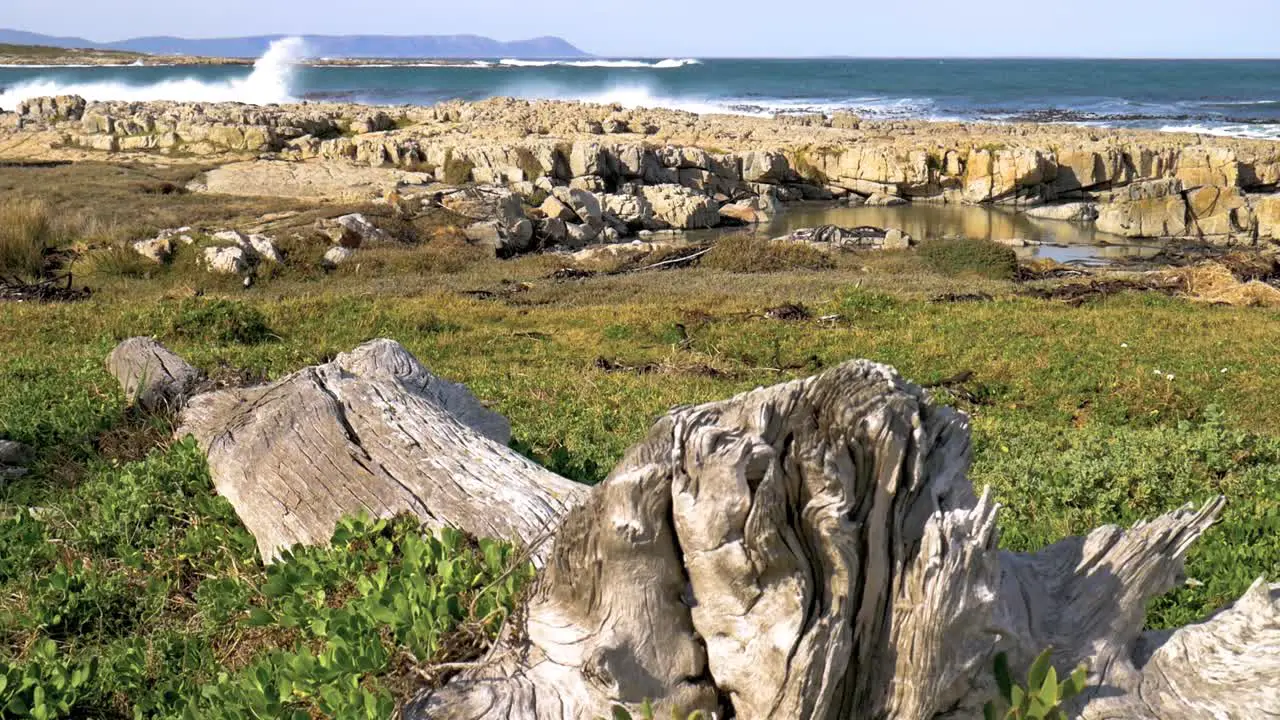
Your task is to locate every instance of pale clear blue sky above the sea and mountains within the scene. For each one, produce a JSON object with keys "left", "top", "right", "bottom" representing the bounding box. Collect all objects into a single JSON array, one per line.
[{"left": 0, "top": 0, "right": 1280, "bottom": 58}]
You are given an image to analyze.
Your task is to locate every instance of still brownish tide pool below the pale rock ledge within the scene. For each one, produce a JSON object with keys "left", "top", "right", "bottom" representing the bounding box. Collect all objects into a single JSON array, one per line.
[{"left": 689, "top": 202, "right": 1162, "bottom": 264}]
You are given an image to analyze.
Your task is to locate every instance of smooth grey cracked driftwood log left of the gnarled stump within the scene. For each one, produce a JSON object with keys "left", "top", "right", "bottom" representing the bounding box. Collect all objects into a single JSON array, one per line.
[{"left": 111, "top": 340, "right": 586, "bottom": 560}]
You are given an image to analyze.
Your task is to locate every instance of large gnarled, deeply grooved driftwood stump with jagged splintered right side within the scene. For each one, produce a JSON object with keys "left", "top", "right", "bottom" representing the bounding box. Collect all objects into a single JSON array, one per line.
[{"left": 406, "top": 363, "right": 1280, "bottom": 720}]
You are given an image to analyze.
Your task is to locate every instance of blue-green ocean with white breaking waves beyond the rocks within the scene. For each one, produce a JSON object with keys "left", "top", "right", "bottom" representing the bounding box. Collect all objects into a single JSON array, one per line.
[{"left": 0, "top": 41, "right": 1280, "bottom": 140}]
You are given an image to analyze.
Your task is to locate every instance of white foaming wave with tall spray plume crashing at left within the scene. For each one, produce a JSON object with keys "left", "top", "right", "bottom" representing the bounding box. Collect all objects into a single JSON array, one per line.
[{"left": 0, "top": 37, "right": 306, "bottom": 110}]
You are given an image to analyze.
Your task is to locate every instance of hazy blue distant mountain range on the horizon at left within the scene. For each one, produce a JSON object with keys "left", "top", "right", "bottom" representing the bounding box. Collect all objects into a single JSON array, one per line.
[{"left": 0, "top": 28, "right": 588, "bottom": 59}]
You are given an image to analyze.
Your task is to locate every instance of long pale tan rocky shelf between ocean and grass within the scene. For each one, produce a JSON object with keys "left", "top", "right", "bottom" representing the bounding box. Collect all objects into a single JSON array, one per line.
[{"left": 0, "top": 97, "right": 1280, "bottom": 255}]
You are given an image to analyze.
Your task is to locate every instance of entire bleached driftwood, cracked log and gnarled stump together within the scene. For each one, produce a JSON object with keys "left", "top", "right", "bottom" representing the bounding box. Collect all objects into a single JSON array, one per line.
[{"left": 104, "top": 341, "right": 1280, "bottom": 720}]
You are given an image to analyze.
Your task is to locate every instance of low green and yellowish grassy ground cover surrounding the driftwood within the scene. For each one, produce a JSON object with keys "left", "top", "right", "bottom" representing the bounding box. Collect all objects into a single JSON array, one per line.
[{"left": 0, "top": 159, "right": 1280, "bottom": 719}]
